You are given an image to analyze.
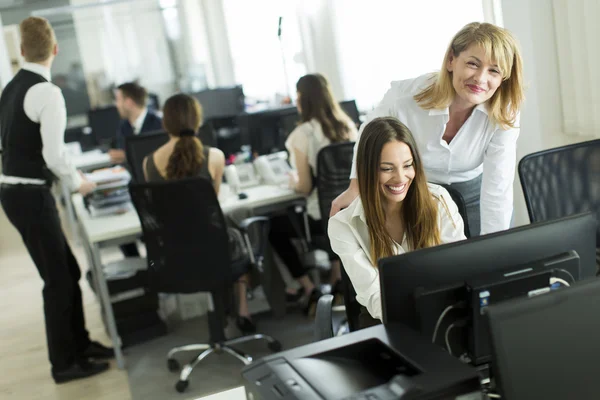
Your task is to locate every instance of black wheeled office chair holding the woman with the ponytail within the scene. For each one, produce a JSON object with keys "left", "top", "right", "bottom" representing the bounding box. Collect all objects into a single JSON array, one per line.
[{"left": 129, "top": 178, "right": 281, "bottom": 392}]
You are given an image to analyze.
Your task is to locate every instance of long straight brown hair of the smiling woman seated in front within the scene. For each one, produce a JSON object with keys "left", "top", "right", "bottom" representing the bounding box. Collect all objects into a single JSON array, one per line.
[{"left": 356, "top": 117, "right": 441, "bottom": 266}]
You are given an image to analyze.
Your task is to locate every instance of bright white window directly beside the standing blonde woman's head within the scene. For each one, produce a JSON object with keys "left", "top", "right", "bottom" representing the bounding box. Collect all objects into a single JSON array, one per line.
[{"left": 332, "top": 0, "right": 484, "bottom": 110}]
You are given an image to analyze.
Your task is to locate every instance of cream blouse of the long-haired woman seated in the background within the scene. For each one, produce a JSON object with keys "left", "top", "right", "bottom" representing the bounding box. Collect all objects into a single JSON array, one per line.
[{"left": 285, "top": 118, "right": 357, "bottom": 221}]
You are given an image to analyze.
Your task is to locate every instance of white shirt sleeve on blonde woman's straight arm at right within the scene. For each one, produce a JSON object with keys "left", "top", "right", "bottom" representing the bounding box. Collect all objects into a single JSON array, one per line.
[{"left": 480, "top": 120, "right": 519, "bottom": 235}]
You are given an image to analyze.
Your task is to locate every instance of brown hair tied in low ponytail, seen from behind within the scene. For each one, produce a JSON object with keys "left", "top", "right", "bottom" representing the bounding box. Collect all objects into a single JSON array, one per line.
[{"left": 163, "top": 93, "right": 204, "bottom": 179}]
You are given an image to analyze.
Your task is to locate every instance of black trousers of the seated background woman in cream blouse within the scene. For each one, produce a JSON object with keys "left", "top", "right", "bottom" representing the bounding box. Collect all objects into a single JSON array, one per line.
[{"left": 269, "top": 215, "right": 324, "bottom": 279}]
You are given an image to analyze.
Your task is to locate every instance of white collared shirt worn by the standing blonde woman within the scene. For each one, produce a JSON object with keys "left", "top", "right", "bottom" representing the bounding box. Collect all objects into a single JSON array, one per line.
[{"left": 350, "top": 75, "right": 519, "bottom": 235}]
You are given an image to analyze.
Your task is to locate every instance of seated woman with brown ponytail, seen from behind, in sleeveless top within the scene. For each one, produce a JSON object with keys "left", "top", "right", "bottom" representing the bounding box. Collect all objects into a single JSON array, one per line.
[{"left": 143, "top": 94, "right": 256, "bottom": 333}]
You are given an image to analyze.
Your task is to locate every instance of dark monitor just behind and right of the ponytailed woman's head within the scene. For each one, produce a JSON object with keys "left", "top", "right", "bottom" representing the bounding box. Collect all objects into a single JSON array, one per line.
[{"left": 192, "top": 86, "right": 245, "bottom": 119}]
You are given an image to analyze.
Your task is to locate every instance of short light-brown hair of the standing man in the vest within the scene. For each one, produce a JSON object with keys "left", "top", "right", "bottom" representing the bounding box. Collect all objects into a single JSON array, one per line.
[{"left": 19, "top": 17, "right": 56, "bottom": 62}]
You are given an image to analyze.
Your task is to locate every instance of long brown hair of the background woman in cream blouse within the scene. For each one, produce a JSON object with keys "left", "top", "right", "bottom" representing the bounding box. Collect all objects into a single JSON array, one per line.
[{"left": 296, "top": 74, "right": 350, "bottom": 143}]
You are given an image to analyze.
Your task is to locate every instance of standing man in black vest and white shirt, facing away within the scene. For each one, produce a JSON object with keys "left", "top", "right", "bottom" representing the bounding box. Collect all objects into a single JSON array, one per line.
[{"left": 0, "top": 17, "right": 114, "bottom": 383}]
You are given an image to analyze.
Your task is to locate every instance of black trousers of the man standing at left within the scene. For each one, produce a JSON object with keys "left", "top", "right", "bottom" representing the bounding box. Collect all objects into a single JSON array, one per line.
[{"left": 0, "top": 185, "right": 90, "bottom": 371}]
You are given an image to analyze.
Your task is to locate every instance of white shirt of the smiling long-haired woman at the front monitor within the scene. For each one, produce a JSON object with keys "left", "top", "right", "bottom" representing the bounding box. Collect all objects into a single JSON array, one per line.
[{"left": 328, "top": 184, "right": 466, "bottom": 320}]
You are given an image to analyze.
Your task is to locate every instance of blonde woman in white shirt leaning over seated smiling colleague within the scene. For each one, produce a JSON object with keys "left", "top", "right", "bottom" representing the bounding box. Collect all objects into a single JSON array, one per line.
[{"left": 331, "top": 22, "right": 524, "bottom": 235}]
